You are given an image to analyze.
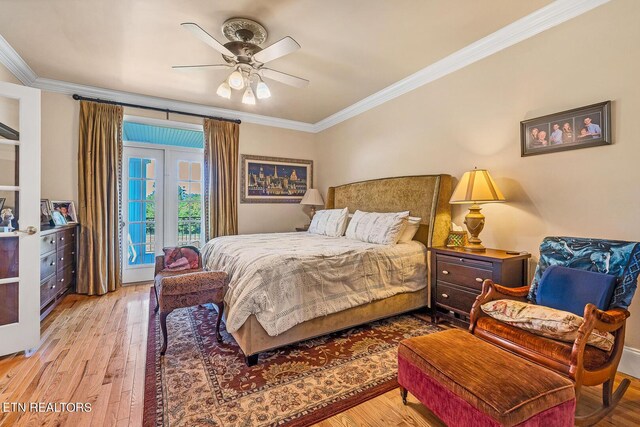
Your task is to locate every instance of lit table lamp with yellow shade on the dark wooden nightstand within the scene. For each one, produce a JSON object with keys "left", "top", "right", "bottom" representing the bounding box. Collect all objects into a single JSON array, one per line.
[{"left": 449, "top": 168, "right": 505, "bottom": 252}]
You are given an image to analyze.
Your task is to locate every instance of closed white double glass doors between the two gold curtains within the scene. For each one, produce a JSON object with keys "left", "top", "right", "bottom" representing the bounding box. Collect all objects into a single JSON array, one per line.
[{"left": 122, "top": 144, "right": 203, "bottom": 283}]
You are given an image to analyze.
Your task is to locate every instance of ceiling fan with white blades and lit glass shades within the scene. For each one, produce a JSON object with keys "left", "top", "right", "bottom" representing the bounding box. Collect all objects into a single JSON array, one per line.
[{"left": 172, "top": 18, "right": 309, "bottom": 105}]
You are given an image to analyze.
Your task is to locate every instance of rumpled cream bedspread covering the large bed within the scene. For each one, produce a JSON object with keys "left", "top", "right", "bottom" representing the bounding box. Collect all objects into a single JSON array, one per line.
[{"left": 202, "top": 232, "right": 427, "bottom": 336}]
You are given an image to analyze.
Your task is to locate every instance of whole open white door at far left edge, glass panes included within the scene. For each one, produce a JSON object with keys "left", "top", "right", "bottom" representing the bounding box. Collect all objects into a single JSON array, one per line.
[{"left": 0, "top": 82, "right": 40, "bottom": 355}]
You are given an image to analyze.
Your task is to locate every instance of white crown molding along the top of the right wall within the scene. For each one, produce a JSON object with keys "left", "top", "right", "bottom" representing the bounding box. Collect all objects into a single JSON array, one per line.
[{"left": 314, "top": 0, "right": 610, "bottom": 132}]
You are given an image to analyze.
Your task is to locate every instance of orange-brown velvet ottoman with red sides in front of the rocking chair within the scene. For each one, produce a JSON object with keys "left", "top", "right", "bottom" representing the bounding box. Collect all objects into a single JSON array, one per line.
[{"left": 398, "top": 329, "right": 576, "bottom": 427}]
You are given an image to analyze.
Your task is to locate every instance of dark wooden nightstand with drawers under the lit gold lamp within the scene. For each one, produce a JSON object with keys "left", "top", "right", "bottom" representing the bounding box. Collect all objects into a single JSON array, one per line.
[{"left": 431, "top": 247, "right": 531, "bottom": 323}]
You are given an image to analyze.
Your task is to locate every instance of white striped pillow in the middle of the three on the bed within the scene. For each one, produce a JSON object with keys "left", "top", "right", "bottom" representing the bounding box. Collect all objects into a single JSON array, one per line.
[{"left": 347, "top": 211, "right": 409, "bottom": 245}]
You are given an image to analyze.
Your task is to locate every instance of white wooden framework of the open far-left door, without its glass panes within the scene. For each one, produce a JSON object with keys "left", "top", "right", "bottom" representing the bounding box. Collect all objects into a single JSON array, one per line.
[{"left": 0, "top": 82, "right": 41, "bottom": 355}]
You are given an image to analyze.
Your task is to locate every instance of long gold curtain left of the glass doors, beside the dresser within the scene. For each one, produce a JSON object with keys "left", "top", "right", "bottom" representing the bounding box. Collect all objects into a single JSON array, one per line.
[{"left": 77, "top": 101, "right": 123, "bottom": 295}]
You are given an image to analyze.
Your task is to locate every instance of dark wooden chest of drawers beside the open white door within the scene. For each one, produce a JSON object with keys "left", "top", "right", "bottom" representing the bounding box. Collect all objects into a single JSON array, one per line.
[{"left": 40, "top": 224, "right": 78, "bottom": 319}]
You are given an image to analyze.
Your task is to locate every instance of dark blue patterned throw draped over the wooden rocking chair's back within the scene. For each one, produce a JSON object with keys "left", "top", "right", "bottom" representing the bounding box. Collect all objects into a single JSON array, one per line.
[{"left": 529, "top": 237, "right": 640, "bottom": 309}]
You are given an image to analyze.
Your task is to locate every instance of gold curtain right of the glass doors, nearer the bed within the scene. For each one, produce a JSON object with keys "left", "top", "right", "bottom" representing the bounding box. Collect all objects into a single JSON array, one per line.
[{"left": 204, "top": 119, "right": 240, "bottom": 240}]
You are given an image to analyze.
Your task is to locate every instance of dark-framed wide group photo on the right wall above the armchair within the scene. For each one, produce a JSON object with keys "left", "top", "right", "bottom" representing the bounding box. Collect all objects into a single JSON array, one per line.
[{"left": 520, "top": 101, "right": 612, "bottom": 157}]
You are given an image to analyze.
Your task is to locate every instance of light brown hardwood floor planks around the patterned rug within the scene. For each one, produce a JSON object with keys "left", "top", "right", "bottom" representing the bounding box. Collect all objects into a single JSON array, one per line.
[{"left": 0, "top": 285, "right": 640, "bottom": 427}]
